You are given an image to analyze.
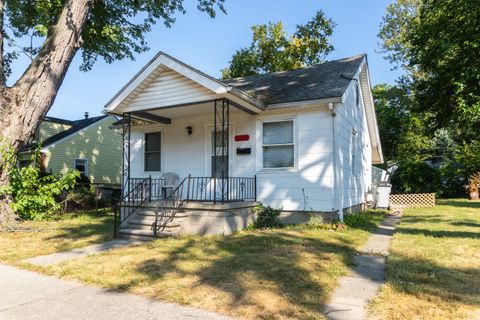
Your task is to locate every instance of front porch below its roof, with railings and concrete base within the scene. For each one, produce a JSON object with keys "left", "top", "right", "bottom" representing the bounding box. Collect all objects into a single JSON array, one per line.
[{"left": 115, "top": 98, "right": 257, "bottom": 238}]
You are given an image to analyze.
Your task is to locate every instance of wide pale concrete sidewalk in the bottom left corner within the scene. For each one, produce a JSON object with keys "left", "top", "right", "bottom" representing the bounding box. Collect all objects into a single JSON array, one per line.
[{"left": 0, "top": 264, "right": 229, "bottom": 320}]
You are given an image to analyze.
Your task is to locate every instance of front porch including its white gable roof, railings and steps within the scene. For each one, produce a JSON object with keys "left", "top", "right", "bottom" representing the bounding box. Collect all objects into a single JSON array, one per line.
[{"left": 105, "top": 53, "right": 265, "bottom": 238}]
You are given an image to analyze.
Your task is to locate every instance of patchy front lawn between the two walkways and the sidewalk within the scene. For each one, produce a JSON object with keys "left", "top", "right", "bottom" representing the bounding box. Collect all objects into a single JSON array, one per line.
[{"left": 48, "top": 216, "right": 381, "bottom": 319}]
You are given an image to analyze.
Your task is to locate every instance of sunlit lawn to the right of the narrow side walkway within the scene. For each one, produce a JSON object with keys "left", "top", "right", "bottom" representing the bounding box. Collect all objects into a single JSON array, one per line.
[{"left": 371, "top": 200, "right": 480, "bottom": 319}]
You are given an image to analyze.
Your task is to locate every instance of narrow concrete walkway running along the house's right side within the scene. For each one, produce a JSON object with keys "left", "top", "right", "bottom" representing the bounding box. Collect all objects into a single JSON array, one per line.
[{"left": 325, "top": 216, "right": 400, "bottom": 320}]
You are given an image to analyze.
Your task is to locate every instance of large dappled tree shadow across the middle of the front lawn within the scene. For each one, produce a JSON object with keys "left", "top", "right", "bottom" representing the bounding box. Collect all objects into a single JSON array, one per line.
[{"left": 108, "top": 230, "right": 355, "bottom": 317}]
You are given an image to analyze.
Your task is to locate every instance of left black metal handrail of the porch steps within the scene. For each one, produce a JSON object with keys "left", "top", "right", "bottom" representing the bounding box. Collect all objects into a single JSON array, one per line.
[{"left": 113, "top": 177, "right": 152, "bottom": 238}]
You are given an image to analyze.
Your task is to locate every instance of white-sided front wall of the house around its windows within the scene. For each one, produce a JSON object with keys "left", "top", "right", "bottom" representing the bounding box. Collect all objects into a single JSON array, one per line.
[{"left": 131, "top": 107, "right": 333, "bottom": 211}]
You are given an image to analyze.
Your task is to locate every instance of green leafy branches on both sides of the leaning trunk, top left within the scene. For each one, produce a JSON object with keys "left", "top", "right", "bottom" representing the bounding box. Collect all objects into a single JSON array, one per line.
[{"left": 5, "top": 0, "right": 226, "bottom": 74}]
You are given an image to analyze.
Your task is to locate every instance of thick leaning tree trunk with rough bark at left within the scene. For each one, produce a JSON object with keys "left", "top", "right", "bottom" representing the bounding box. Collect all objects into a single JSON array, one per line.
[{"left": 0, "top": 0, "right": 93, "bottom": 221}]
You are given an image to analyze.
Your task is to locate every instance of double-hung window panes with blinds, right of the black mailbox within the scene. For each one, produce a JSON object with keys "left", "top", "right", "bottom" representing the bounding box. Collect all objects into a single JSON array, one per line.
[{"left": 263, "top": 120, "right": 294, "bottom": 168}]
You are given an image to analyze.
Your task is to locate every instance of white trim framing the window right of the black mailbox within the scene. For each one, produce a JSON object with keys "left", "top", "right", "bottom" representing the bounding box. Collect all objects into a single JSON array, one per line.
[{"left": 257, "top": 115, "right": 298, "bottom": 173}]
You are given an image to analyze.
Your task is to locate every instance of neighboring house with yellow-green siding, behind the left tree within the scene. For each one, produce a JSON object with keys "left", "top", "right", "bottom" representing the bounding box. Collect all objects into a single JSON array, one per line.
[{"left": 20, "top": 114, "right": 122, "bottom": 187}]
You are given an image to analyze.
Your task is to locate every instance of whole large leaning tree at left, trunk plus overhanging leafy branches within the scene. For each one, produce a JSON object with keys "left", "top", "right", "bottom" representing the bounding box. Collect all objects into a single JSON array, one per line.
[{"left": 0, "top": 0, "right": 225, "bottom": 223}]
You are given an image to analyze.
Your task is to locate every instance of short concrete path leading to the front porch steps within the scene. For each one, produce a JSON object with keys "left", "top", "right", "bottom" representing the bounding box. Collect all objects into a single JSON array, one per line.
[{"left": 22, "top": 239, "right": 142, "bottom": 267}]
